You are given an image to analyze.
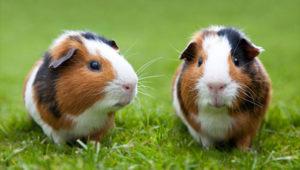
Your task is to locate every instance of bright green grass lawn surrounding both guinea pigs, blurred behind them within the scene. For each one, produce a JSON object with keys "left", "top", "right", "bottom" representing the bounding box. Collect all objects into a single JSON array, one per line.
[{"left": 0, "top": 0, "right": 300, "bottom": 169}]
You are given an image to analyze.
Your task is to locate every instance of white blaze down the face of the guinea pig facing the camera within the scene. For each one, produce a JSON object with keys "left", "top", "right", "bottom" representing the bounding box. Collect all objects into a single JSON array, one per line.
[{"left": 196, "top": 35, "right": 239, "bottom": 107}]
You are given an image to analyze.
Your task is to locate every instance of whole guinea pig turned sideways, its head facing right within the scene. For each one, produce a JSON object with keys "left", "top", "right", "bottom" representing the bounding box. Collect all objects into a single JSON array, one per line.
[{"left": 23, "top": 31, "right": 138, "bottom": 144}]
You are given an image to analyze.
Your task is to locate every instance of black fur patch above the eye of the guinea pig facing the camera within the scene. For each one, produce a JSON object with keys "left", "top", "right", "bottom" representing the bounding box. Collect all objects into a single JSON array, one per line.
[{"left": 218, "top": 28, "right": 252, "bottom": 67}]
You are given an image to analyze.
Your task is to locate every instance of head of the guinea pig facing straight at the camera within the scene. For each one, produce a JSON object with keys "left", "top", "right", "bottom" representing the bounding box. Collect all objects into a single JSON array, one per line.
[{"left": 181, "top": 27, "right": 262, "bottom": 108}]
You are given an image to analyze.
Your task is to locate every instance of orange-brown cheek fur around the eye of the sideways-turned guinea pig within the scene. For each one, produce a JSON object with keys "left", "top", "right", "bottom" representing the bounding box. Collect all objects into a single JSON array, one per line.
[{"left": 56, "top": 53, "right": 115, "bottom": 115}]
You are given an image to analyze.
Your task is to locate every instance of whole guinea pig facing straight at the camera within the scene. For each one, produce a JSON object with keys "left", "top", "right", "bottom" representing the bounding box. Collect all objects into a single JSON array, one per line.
[{"left": 172, "top": 26, "right": 271, "bottom": 150}]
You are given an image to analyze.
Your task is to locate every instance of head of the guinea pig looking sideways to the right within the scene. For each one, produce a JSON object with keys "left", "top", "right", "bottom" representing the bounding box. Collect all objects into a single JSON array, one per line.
[{"left": 49, "top": 31, "right": 138, "bottom": 115}]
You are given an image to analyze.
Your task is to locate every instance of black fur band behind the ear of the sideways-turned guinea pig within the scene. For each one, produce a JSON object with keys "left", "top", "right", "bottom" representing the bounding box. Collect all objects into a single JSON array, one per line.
[{"left": 33, "top": 52, "right": 61, "bottom": 118}]
